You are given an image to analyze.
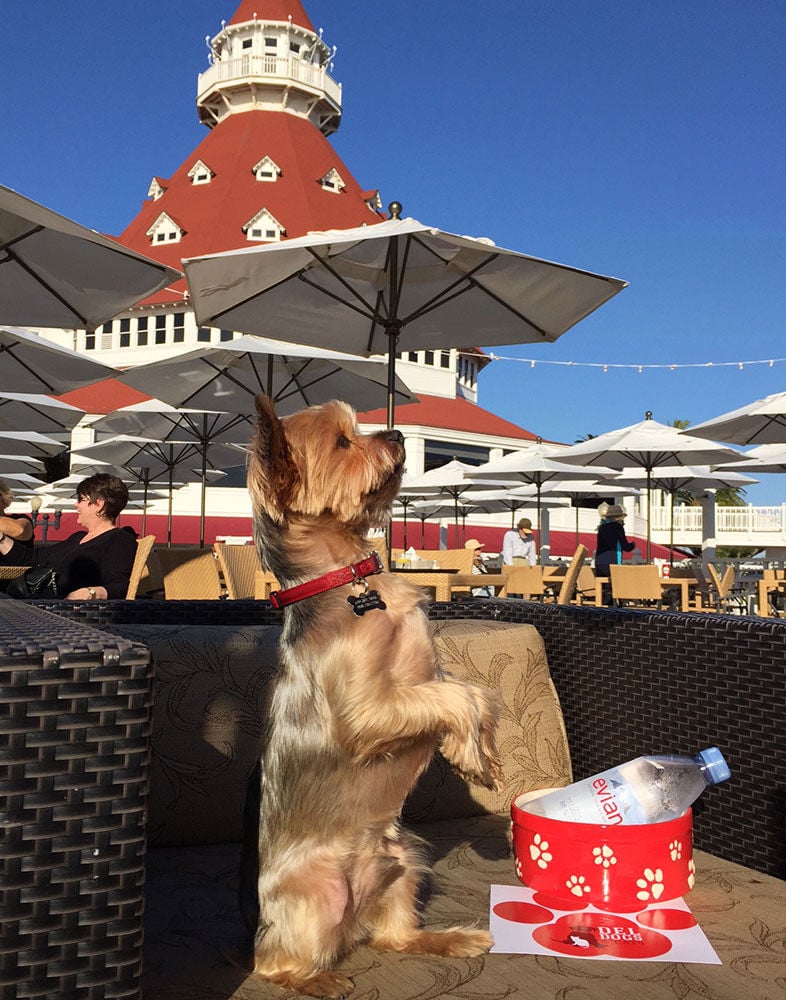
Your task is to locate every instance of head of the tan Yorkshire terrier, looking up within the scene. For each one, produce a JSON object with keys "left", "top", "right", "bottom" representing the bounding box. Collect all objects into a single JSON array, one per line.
[{"left": 248, "top": 395, "right": 404, "bottom": 530}]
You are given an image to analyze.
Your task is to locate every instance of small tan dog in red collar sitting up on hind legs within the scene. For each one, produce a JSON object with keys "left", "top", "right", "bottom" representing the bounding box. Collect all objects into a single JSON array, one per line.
[{"left": 248, "top": 396, "right": 501, "bottom": 997}]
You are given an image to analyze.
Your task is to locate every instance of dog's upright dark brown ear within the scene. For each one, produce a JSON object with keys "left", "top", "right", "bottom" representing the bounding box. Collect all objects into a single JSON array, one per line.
[{"left": 248, "top": 393, "right": 300, "bottom": 523}]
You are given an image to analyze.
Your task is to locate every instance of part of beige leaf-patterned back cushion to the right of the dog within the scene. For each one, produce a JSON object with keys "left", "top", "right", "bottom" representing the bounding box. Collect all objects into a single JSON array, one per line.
[{"left": 404, "top": 619, "right": 573, "bottom": 822}]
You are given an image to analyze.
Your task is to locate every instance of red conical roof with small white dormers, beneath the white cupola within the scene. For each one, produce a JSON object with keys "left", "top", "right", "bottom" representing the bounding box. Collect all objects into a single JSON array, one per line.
[{"left": 120, "top": 111, "right": 383, "bottom": 288}]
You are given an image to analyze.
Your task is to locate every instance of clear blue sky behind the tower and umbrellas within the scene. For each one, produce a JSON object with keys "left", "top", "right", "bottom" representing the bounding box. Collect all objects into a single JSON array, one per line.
[{"left": 6, "top": 0, "right": 786, "bottom": 503}]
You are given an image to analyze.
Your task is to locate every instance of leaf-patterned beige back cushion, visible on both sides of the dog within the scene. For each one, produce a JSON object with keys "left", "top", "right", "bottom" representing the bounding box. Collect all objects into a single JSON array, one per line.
[{"left": 112, "top": 620, "right": 571, "bottom": 846}]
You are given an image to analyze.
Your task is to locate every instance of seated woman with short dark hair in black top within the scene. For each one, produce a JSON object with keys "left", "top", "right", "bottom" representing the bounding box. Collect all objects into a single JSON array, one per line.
[{"left": 27, "top": 472, "right": 136, "bottom": 601}]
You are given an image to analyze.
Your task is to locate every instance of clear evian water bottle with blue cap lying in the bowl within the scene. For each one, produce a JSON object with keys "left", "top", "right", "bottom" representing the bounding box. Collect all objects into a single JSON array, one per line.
[{"left": 520, "top": 747, "right": 731, "bottom": 826}]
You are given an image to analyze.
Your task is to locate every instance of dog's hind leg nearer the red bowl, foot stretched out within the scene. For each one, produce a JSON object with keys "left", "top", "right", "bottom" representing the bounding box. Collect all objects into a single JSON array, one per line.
[{"left": 364, "top": 832, "right": 493, "bottom": 958}]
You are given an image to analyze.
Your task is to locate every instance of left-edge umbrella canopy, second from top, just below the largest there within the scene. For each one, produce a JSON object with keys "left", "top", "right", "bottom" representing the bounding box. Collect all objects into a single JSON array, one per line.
[{"left": 0, "top": 326, "right": 117, "bottom": 395}]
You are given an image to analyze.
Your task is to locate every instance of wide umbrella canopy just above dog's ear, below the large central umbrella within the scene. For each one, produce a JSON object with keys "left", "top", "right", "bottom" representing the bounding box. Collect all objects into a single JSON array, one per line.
[{"left": 120, "top": 337, "right": 414, "bottom": 416}]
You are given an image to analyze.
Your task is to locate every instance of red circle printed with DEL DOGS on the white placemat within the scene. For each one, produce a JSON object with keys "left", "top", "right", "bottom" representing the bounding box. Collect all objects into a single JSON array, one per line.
[{"left": 532, "top": 913, "right": 671, "bottom": 961}]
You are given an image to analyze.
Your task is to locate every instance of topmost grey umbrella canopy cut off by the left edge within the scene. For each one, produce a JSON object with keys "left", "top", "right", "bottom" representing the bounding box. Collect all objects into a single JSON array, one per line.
[{"left": 0, "top": 186, "right": 181, "bottom": 330}]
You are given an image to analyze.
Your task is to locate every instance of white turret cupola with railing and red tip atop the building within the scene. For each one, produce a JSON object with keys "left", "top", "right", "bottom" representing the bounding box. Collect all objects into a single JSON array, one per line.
[{"left": 197, "top": 0, "right": 341, "bottom": 135}]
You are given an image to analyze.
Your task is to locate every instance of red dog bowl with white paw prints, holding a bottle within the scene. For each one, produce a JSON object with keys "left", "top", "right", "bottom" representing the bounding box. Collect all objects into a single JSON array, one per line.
[{"left": 511, "top": 793, "right": 695, "bottom": 909}]
